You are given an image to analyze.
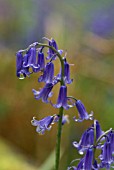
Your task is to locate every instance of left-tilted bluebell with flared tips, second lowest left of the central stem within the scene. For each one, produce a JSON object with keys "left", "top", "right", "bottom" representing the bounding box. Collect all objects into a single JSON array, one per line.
[{"left": 32, "top": 83, "right": 53, "bottom": 103}]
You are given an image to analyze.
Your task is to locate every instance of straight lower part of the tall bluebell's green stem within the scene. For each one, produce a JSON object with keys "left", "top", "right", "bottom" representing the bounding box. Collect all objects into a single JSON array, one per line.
[{"left": 55, "top": 107, "right": 64, "bottom": 170}]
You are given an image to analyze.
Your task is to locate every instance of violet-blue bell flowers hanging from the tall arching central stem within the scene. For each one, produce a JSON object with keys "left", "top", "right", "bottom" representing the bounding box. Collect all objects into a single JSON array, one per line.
[{"left": 16, "top": 38, "right": 92, "bottom": 134}]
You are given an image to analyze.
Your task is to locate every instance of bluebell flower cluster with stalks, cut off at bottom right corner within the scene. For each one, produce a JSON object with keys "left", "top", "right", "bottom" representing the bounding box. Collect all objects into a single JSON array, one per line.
[{"left": 68, "top": 120, "right": 114, "bottom": 170}]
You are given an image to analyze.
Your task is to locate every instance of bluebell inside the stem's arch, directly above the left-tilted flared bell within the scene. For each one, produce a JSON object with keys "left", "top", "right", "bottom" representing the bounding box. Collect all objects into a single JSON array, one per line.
[{"left": 38, "top": 62, "right": 54, "bottom": 83}]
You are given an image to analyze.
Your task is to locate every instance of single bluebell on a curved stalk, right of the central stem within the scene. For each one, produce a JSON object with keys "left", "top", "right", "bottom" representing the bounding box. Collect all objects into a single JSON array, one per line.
[{"left": 74, "top": 100, "right": 93, "bottom": 122}]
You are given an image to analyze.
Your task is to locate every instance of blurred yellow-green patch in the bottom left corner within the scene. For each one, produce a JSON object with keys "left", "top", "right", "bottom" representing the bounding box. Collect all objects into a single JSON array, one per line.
[{"left": 0, "top": 139, "right": 37, "bottom": 170}]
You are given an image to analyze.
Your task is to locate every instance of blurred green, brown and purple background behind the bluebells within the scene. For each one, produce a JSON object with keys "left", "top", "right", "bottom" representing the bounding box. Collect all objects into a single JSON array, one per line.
[{"left": 0, "top": 0, "right": 114, "bottom": 170}]
